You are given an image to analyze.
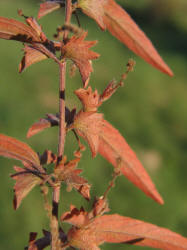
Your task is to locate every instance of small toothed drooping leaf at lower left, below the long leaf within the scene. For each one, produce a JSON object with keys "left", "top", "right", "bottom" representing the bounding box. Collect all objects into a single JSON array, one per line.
[{"left": 11, "top": 166, "right": 42, "bottom": 209}]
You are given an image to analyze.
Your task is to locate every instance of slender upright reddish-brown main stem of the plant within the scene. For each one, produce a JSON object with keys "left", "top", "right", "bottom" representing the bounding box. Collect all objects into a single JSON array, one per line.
[{"left": 51, "top": 0, "right": 72, "bottom": 250}]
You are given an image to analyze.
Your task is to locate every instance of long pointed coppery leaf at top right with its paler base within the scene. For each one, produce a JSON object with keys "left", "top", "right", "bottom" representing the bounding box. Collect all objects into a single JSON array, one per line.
[{"left": 78, "top": 0, "right": 173, "bottom": 76}]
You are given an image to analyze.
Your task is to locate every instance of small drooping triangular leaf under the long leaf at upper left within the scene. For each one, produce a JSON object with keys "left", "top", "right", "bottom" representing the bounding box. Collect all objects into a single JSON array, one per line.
[{"left": 19, "top": 45, "right": 47, "bottom": 73}]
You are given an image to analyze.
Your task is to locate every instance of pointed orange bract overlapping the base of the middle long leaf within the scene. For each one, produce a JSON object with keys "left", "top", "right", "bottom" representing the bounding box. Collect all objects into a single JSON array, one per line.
[{"left": 74, "top": 111, "right": 103, "bottom": 157}]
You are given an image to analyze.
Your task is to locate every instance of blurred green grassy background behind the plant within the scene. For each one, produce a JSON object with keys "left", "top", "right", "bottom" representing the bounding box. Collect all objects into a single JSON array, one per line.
[{"left": 0, "top": 0, "right": 187, "bottom": 250}]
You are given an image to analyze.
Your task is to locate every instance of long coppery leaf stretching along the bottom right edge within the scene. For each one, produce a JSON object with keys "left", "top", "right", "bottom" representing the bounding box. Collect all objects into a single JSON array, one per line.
[{"left": 68, "top": 214, "right": 187, "bottom": 250}]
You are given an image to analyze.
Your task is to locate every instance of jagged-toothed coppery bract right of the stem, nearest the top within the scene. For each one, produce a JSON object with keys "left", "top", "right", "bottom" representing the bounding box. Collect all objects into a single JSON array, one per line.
[{"left": 62, "top": 32, "right": 99, "bottom": 87}]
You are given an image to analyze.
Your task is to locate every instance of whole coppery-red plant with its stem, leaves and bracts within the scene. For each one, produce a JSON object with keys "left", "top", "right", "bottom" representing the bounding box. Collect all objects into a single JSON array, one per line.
[{"left": 0, "top": 0, "right": 187, "bottom": 249}]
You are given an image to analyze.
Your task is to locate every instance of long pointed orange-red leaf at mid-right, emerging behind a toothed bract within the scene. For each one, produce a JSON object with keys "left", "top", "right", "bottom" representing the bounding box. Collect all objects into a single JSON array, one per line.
[{"left": 98, "top": 120, "right": 163, "bottom": 204}]
